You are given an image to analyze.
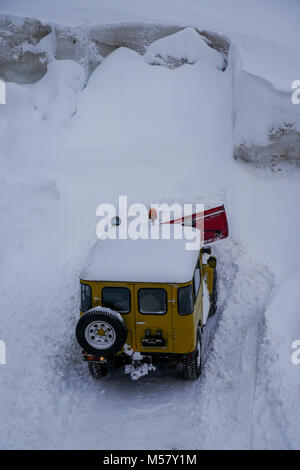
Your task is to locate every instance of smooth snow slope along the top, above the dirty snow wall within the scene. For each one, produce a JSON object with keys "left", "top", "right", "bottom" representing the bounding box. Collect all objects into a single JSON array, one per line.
[{"left": 1, "top": 0, "right": 300, "bottom": 49}]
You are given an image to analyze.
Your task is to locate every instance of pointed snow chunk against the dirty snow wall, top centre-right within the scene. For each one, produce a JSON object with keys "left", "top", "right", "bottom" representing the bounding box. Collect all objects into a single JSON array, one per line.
[{"left": 144, "top": 28, "right": 224, "bottom": 69}]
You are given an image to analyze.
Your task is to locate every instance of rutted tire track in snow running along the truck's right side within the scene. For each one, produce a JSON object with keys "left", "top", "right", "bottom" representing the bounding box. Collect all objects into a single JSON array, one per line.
[{"left": 176, "top": 243, "right": 271, "bottom": 449}]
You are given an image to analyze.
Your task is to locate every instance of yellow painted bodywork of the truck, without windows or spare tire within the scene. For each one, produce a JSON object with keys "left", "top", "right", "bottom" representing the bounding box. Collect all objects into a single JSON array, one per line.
[{"left": 80, "top": 252, "right": 214, "bottom": 354}]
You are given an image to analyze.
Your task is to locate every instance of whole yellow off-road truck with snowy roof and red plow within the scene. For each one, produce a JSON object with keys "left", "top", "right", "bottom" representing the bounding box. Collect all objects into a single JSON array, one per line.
[{"left": 76, "top": 206, "right": 228, "bottom": 380}]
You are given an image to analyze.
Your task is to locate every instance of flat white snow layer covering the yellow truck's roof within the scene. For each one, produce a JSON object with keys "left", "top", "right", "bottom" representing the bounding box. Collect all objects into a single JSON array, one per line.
[{"left": 81, "top": 227, "right": 199, "bottom": 283}]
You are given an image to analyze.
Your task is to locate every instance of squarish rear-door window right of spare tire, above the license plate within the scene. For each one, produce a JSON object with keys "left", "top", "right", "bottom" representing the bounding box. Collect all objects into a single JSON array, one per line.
[{"left": 138, "top": 287, "right": 167, "bottom": 315}]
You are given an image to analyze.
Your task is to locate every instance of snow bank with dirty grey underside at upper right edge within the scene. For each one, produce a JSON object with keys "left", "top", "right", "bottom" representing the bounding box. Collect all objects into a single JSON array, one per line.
[{"left": 233, "top": 58, "right": 300, "bottom": 172}]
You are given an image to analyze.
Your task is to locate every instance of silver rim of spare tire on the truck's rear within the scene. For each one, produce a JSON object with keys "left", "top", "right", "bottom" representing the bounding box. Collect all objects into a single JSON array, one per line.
[{"left": 85, "top": 321, "right": 116, "bottom": 349}]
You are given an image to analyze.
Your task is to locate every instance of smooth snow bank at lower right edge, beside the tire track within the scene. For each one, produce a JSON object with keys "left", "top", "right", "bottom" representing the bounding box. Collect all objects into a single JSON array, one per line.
[{"left": 260, "top": 265, "right": 300, "bottom": 449}]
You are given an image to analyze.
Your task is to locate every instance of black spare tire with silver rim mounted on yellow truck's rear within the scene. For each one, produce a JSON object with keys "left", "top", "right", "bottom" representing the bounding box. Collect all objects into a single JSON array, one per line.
[{"left": 76, "top": 307, "right": 127, "bottom": 357}]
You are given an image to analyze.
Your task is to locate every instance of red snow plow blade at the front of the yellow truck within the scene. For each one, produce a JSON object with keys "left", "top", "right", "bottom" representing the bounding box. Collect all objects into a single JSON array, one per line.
[{"left": 165, "top": 206, "right": 229, "bottom": 245}]
